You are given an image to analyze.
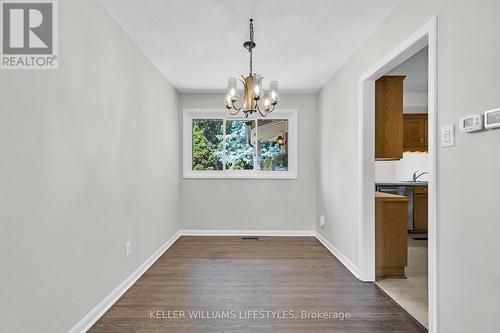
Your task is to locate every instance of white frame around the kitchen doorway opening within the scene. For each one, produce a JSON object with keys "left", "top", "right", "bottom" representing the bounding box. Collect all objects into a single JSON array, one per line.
[{"left": 358, "top": 17, "right": 438, "bottom": 333}]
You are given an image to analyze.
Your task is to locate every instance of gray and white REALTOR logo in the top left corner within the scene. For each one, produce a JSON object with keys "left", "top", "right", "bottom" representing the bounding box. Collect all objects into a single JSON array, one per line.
[{"left": 0, "top": 0, "right": 58, "bottom": 69}]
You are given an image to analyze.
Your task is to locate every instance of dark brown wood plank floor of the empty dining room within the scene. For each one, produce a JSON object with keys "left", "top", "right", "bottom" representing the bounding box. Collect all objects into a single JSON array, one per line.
[{"left": 89, "top": 237, "right": 426, "bottom": 333}]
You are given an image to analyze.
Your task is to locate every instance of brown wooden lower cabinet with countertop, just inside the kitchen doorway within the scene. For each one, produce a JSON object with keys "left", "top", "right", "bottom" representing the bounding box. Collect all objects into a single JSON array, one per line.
[{"left": 375, "top": 192, "right": 408, "bottom": 278}]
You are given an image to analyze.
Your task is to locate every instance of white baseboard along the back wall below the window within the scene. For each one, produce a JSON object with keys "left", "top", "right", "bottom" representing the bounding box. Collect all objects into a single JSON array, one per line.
[{"left": 179, "top": 229, "right": 316, "bottom": 237}]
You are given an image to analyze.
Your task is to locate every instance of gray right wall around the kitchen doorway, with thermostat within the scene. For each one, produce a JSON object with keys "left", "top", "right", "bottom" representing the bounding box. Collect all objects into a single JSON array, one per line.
[{"left": 317, "top": 0, "right": 500, "bottom": 332}]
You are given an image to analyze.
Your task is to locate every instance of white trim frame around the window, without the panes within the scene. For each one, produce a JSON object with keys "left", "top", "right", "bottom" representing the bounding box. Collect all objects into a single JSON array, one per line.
[{"left": 186, "top": 109, "right": 298, "bottom": 179}]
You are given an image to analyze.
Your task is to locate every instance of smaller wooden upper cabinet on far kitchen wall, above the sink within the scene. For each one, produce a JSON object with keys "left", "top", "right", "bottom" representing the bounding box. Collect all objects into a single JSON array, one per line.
[{"left": 403, "top": 114, "right": 428, "bottom": 152}]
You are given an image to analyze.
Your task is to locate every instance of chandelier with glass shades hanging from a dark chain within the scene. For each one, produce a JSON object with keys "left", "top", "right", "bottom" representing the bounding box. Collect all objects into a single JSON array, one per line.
[{"left": 225, "top": 19, "right": 279, "bottom": 117}]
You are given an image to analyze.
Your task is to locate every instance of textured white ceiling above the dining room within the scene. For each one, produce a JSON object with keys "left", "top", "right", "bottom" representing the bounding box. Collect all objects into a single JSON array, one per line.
[{"left": 100, "top": 0, "right": 400, "bottom": 92}]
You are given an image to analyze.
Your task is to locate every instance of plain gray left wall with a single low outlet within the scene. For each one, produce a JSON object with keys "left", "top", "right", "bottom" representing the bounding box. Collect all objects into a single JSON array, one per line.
[{"left": 0, "top": 0, "right": 180, "bottom": 333}]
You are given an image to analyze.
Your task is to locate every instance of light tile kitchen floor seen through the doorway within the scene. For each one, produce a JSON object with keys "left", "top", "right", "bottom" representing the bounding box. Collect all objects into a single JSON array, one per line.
[{"left": 376, "top": 234, "right": 429, "bottom": 328}]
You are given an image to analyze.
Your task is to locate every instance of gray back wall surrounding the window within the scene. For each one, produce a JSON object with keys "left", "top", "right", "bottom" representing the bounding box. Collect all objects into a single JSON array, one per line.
[{"left": 180, "top": 93, "right": 316, "bottom": 231}]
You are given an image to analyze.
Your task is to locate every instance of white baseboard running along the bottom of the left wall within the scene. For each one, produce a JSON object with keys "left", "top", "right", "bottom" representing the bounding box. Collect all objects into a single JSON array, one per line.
[{"left": 68, "top": 231, "right": 181, "bottom": 333}]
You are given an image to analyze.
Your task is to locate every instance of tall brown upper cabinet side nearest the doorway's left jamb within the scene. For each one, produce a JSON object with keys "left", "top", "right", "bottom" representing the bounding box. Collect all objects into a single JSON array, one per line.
[{"left": 375, "top": 76, "right": 406, "bottom": 160}]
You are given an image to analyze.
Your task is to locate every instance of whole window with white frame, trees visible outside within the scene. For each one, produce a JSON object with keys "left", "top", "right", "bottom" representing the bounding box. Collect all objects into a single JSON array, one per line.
[{"left": 183, "top": 110, "right": 297, "bottom": 179}]
